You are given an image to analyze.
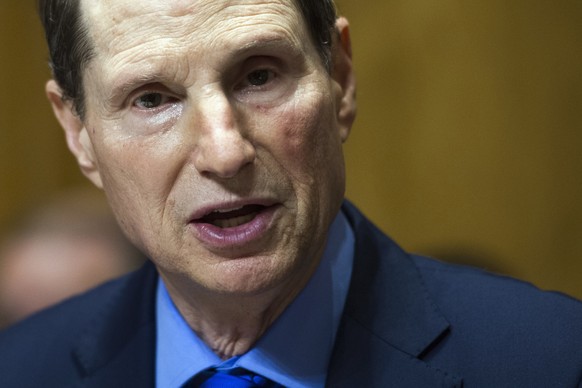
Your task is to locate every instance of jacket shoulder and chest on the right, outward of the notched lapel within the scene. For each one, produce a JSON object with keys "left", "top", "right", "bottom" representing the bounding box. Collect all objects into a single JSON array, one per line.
[{"left": 412, "top": 256, "right": 582, "bottom": 386}]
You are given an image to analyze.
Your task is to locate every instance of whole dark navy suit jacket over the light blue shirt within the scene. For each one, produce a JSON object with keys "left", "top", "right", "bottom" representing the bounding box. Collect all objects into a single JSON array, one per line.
[{"left": 0, "top": 203, "right": 582, "bottom": 388}]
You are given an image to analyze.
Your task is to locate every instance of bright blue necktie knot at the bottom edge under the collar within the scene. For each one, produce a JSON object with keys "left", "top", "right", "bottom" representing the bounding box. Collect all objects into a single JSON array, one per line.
[{"left": 182, "top": 367, "right": 282, "bottom": 388}]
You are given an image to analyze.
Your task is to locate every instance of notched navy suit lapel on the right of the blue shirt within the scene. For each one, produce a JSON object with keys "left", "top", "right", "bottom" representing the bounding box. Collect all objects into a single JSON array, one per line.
[{"left": 328, "top": 203, "right": 461, "bottom": 387}]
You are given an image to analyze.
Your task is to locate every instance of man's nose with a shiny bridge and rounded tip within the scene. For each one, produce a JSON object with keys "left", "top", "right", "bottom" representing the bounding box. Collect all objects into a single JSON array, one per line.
[{"left": 194, "top": 96, "right": 256, "bottom": 178}]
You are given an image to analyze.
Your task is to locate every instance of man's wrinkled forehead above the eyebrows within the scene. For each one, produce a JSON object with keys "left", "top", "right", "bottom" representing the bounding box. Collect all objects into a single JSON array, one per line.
[{"left": 81, "top": 0, "right": 317, "bottom": 84}]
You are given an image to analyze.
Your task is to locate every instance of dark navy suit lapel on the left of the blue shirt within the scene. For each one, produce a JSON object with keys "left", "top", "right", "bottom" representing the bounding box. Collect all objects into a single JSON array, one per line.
[{"left": 73, "top": 263, "right": 157, "bottom": 388}]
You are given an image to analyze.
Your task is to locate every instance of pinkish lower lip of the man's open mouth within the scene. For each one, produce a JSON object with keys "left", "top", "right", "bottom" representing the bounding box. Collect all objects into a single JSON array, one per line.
[{"left": 190, "top": 206, "right": 278, "bottom": 250}]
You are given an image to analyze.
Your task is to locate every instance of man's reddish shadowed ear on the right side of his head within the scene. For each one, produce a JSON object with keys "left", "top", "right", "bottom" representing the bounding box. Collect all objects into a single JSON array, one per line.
[{"left": 332, "top": 17, "right": 356, "bottom": 141}]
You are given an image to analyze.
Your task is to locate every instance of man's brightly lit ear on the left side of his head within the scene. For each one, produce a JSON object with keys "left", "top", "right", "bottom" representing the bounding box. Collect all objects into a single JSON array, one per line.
[{"left": 46, "top": 80, "right": 103, "bottom": 188}]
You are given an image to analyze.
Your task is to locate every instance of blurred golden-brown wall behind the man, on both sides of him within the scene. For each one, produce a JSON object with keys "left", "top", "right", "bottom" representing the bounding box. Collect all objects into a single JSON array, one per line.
[{"left": 0, "top": 0, "right": 582, "bottom": 298}]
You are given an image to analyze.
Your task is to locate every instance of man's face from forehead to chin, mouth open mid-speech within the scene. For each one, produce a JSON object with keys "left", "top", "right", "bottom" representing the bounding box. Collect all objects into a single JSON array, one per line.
[{"left": 62, "top": 0, "right": 353, "bottom": 294}]
